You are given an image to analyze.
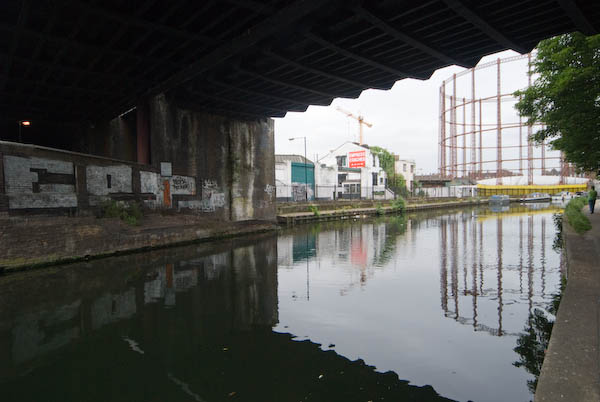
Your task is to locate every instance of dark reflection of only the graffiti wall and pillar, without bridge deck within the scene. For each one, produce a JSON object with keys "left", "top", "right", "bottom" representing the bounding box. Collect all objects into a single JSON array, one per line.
[{"left": 0, "top": 236, "right": 278, "bottom": 382}]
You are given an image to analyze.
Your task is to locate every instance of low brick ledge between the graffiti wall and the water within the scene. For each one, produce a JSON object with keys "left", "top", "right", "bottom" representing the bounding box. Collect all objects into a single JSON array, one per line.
[{"left": 0, "top": 214, "right": 277, "bottom": 271}]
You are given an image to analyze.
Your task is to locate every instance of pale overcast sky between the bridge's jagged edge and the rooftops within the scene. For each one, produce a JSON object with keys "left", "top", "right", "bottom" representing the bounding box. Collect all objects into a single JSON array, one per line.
[{"left": 274, "top": 51, "right": 540, "bottom": 174}]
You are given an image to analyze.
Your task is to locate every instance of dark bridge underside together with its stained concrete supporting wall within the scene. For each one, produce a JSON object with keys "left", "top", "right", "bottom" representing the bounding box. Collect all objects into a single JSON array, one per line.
[{"left": 0, "top": 0, "right": 600, "bottom": 220}]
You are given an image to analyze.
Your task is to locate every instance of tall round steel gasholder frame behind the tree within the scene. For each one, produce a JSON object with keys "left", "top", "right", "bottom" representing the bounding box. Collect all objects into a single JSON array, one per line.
[{"left": 438, "top": 53, "right": 574, "bottom": 185}]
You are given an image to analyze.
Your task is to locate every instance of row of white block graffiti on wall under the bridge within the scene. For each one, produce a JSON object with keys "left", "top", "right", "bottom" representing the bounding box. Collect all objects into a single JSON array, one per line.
[{"left": 0, "top": 155, "right": 199, "bottom": 212}]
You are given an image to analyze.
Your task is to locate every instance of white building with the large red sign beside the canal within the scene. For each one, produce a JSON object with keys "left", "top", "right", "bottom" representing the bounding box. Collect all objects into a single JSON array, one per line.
[{"left": 317, "top": 142, "right": 394, "bottom": 199}]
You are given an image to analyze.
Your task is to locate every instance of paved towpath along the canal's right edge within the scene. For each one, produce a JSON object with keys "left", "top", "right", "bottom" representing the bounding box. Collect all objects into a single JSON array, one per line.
[{"left": 535, "top": 206, "right": 600, "bottom": 402}]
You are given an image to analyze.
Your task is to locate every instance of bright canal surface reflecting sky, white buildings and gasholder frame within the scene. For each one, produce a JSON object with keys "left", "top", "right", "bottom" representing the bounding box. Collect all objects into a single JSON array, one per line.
[{"left": 275, "top": 204, "right": 564, "bottom": 401}]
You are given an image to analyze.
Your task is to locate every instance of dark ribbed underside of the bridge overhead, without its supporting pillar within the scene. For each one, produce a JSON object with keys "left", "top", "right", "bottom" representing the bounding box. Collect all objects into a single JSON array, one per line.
[{"left": 0, "top": 0, "right": 600, "bottom": 121}]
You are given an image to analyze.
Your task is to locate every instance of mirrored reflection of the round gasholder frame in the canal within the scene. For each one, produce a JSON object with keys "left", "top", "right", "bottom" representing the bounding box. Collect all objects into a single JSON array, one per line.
[{"left": 439, "top": 209, "right": 562, "bottom": 336}]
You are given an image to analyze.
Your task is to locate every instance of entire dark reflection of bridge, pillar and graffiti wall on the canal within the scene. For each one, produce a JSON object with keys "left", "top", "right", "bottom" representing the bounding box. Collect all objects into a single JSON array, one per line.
[{"left": 0, "top": 235, "right": 448, "bottom": 401}]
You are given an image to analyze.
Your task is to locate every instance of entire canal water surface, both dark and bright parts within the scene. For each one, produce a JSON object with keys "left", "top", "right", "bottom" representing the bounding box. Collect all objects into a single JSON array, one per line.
[{"left": 0, "top": 205, "right": 564, "bottom": 402}]
